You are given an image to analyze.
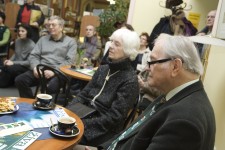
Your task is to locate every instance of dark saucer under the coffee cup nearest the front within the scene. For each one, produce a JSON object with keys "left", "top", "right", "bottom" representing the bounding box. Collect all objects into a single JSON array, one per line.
[{"left": 49, "top": 124, "right": 80, "bottom": 137}]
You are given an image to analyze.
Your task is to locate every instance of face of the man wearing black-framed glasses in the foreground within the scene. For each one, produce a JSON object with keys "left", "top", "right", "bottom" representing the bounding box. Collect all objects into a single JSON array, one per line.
[{"left": 147, "top": 44, "right": 171, "bottom": 92}]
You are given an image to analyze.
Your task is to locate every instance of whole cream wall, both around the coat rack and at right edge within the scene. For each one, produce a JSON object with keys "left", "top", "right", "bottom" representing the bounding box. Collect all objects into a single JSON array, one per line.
[{"left": 128, "top": 0, "right": 225, "bottom": 150}]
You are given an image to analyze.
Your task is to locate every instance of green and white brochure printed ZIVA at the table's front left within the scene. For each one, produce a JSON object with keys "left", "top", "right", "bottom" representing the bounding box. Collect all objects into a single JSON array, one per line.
[{"left": 0, "top": 131, "right": 41, "bottom": 150}]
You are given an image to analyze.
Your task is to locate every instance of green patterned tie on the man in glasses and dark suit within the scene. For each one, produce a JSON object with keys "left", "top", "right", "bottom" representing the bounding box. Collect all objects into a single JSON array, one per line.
[{"left": 107, "top": 97, "right": 165, "bottom": 150}]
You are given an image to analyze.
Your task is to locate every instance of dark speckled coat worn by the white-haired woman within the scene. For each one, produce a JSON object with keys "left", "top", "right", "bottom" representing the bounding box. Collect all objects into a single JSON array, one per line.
[{"left": 77, "top": 59, "right": 139, "bottom": 143}]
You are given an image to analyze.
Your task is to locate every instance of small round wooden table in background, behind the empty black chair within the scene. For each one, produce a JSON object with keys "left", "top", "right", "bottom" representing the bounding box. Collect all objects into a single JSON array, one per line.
[{"left": 59, "top": 66, "right": 92, "bottom": 81}]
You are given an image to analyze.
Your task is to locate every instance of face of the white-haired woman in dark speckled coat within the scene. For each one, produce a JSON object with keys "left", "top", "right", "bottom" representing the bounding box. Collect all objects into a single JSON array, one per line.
[{"left": 108, "top": 39, "right": 126, "bottom": 61}]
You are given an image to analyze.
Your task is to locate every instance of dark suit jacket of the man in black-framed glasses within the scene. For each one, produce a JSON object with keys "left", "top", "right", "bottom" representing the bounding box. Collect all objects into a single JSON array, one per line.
[{"left": 100, "top": 81, "right": 216, "bottom": 150}]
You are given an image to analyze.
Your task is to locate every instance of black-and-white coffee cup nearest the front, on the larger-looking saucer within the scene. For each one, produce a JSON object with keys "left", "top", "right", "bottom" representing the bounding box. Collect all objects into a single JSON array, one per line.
[{"left": 58, "top": 116, "right": 76, "bottom": 134}]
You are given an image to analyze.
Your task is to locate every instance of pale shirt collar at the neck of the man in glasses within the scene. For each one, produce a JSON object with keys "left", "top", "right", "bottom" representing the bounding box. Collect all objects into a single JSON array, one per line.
[{"left": 166, "top": 79, "right": 199, "bottom": 101}]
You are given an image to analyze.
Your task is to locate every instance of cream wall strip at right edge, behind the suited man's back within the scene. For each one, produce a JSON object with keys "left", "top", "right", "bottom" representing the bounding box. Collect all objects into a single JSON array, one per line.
[{"left": 204, "top": 46, "right": 225, "bottom": 150}]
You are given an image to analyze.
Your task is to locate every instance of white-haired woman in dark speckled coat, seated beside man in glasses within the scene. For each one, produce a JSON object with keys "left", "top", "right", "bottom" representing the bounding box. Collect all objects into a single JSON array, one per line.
[{"left": 68, "top": 29, "right": 140, "bottom": 146}]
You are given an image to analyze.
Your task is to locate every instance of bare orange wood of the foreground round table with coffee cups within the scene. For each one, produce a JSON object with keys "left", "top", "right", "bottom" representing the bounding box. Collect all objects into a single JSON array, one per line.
[{"left": 16, "top": 98, "right": 84, "bottom": 150}]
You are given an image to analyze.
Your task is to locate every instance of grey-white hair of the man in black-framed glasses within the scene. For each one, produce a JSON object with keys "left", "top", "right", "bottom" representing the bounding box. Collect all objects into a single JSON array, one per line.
[{"left": 155, "top": 33, "right": 203, "bottom": 75}]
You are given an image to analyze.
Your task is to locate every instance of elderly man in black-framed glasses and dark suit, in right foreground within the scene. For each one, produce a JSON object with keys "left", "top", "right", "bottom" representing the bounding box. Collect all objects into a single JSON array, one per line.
[{"left": 81, "top": 34, "right": 216, "bottom": 150}]
